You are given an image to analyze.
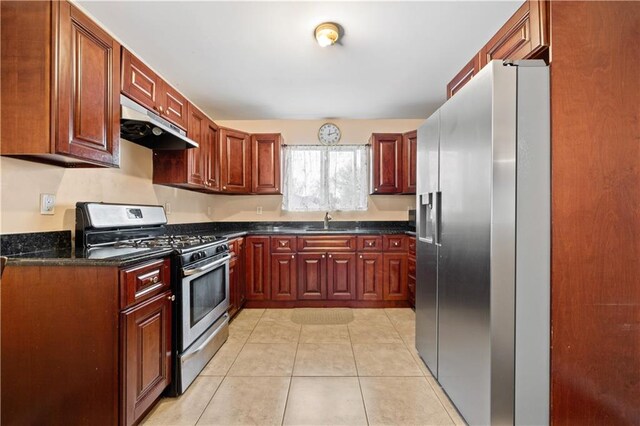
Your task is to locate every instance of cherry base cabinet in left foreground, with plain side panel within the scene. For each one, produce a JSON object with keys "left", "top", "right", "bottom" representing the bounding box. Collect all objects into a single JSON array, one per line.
[{"left": 0, "top": 258, "right": 174, "bottom": 425}]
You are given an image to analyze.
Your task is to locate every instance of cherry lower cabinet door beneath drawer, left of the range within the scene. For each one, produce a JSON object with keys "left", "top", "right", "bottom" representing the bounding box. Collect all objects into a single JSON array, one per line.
[{"left": 121, "top": 291, "right": 172, "bottom": 425}]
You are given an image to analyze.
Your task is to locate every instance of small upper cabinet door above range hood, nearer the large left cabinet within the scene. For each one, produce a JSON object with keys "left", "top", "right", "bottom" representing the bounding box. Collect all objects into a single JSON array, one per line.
[{"left": 122, "top": 49, "right": 162, "bottom": 114}]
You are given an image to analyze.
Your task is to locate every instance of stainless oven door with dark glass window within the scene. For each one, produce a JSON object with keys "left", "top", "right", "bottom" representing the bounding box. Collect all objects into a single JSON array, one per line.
[{"left": 178, "top": 254, "right": 231, "bottom": 352}]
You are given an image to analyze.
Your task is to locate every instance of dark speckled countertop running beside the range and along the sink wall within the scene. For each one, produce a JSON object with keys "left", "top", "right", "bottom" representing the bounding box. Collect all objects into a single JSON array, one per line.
[{"left": 0, "top": 221, "right": 415, "bottom": 267}]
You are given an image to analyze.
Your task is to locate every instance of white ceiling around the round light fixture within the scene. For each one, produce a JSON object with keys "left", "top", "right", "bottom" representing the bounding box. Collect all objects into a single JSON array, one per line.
[{"left": 79, "top": 0, "right": 522, "bottom": 120}]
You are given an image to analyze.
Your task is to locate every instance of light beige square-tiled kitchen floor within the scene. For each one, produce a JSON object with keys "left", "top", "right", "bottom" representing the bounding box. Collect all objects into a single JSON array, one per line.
[{"left": 143, "top": 309, "right": 464, "bottom": 426}]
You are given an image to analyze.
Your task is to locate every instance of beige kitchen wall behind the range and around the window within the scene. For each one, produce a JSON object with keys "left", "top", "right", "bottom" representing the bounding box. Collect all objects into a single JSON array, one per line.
[{"left": 0, "top": 120, "right": 421, "bottom": 233}]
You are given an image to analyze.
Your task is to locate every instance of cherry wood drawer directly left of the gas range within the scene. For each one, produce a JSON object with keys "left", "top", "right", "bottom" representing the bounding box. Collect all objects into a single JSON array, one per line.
[{"left": 120, "top": 258, "right": 171, "bottom": 309}]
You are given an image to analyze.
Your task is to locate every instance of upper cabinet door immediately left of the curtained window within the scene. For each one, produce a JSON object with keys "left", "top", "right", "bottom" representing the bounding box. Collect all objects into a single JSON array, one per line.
[{"left": 251, "top": 133, "right": 281, "bottom": 194}]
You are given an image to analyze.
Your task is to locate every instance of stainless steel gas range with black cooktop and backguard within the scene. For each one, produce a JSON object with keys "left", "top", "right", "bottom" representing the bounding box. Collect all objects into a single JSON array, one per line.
[{"left": 75, "top": 202, "right": 231, "bottom": 396}]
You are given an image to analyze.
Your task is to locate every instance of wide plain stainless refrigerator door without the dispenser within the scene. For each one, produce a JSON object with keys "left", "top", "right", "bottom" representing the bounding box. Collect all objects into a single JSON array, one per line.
[{"left": 438, "top": 66, "right": 492, "bottom": 425}]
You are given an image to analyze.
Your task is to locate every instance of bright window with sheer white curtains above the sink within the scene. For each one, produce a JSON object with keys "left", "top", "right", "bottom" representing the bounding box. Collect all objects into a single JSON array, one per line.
[{"left": 282, "top": 145, "right": 368, "bottom": 212}]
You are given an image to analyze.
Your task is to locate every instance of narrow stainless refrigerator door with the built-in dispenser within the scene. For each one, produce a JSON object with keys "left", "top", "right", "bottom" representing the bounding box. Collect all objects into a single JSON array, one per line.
[{"left": 416, "top": 111, "right": 440, "bottom": 378}]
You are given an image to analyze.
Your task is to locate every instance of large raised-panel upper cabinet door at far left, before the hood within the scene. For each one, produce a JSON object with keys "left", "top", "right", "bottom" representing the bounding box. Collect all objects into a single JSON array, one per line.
[{"left": 56, "top": 2, "right": 120, "bottom": 166}]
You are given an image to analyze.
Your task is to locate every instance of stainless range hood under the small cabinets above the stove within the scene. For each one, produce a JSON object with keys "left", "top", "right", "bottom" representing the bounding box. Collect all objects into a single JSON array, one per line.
[{"left": 120, "top": 95, "right": 198, "bottom": 150}]
